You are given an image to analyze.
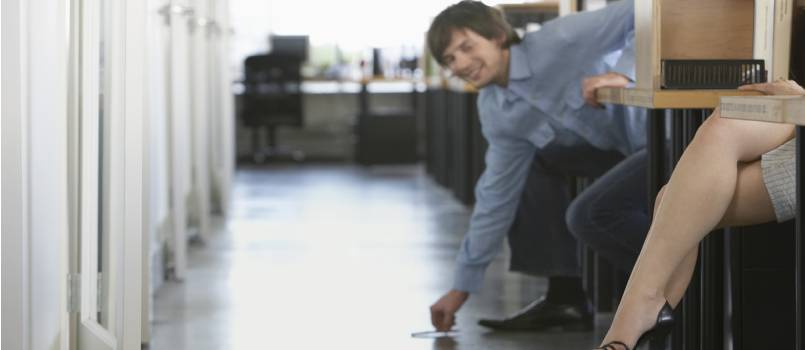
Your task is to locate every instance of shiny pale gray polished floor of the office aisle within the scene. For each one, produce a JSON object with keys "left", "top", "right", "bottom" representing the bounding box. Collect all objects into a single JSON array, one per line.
[{"left": 150, "top": 165, "right": 608, "bottom": 350}]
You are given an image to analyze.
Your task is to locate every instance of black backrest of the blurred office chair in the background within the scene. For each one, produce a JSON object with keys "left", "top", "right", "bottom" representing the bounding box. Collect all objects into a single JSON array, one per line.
[{"left": 242, "top": 54, "right": 303, "bottom": 126}]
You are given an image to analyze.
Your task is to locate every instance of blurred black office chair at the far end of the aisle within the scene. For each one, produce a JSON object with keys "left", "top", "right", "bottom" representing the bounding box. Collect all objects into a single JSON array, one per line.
[{"left": 241, "top": 53, "right": 304, "bottom": 163}]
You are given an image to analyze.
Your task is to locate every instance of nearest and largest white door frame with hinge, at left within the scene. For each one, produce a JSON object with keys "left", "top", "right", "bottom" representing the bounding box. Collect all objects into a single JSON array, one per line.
[{"left": 74, "top": 0, "right": 145, "bottom": 350}]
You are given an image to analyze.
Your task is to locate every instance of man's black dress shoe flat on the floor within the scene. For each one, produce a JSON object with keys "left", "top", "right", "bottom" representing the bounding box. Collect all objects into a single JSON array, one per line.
[{"left": 478, "top": 298, "right": 593, "bottom": 331}]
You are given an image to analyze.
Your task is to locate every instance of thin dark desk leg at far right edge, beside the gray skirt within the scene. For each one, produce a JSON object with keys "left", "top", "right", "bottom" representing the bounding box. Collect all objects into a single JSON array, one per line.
[{"left": 794, "top": 126, "right": 805, "bottom": 350}]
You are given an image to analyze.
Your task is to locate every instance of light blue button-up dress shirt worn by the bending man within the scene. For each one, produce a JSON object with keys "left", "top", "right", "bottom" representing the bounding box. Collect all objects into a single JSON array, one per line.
[{"left": 453, "top": 0, "right": 646, "bottom": 292}]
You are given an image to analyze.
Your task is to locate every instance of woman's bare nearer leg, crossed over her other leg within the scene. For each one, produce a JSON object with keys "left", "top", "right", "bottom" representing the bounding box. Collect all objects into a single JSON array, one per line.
[{"left": 604, "top": 113, "right": 794, "bottom": 346}]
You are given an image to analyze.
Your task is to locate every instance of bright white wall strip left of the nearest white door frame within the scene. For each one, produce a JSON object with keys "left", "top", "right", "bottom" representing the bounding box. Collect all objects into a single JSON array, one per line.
[{"left": 14, "top": 0, "right": 68, "bottom": 349}]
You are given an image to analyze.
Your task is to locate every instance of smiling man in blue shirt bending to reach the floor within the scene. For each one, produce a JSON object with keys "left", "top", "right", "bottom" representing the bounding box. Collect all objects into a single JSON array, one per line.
[{"left": 428, "top": 0, "right": 647, "bottom": 330}]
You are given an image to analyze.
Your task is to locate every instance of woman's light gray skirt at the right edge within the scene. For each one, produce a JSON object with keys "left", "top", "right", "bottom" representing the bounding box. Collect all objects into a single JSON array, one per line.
[{"left": 760, "top": 139, "right": 797, "bottom": 222}]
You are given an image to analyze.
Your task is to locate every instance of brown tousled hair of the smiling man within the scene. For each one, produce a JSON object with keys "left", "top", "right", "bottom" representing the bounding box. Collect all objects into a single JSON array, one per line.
[{"left": 428, "top": 0, "right": 520, "bottom": 66}]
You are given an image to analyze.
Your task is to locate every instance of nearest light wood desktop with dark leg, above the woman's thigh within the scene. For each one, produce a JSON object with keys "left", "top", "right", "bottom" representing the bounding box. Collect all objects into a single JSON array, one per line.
[{"left": 721, "top": 96, "right": 805, "bottom": 350}]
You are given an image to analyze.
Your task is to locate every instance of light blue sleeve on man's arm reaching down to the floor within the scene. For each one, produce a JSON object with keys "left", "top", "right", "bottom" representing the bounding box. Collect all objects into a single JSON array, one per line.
[{"left": 453, "top": 135, "right": 535, "bottom": 293}]
